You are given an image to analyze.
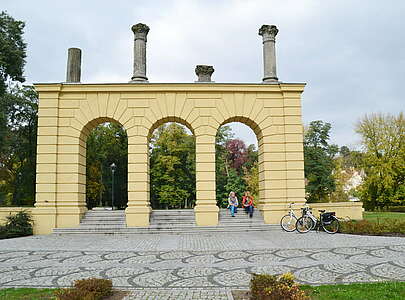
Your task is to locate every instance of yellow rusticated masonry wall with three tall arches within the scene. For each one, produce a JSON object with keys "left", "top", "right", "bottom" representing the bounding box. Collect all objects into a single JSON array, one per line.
[{"left": 30, "top": 83, "right": 322, "bottom": 233}]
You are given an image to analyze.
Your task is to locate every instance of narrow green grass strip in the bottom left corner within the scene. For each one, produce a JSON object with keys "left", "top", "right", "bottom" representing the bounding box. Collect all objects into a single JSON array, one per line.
[{"left": 0, "top": 288, "right": 56, "bottom": 300}]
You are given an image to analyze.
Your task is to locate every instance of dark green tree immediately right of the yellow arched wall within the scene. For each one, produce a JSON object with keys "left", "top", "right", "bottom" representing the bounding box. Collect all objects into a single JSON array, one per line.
[{"left": 304, "top": 121, "right": 338, "bottom": 202}]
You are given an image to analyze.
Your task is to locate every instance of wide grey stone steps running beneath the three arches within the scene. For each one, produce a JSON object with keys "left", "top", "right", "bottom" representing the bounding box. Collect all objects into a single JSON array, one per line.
[{"left": 53, "top": 208, "right": 279, "bottom": 234}]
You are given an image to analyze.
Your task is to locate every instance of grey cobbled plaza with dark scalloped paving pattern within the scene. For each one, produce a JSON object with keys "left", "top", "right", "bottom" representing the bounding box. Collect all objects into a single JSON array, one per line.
[{"left": 0, "top": 230, "right": 405, "bottom": 300}]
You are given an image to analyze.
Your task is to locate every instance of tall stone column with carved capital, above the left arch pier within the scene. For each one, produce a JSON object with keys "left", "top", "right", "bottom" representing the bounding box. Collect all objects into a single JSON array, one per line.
[{"left": 131, "top": 23, "right": 149, "bottom": 82}]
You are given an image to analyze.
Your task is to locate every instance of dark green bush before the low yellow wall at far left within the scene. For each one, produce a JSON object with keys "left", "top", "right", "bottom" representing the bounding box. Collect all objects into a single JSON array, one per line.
[{"left": 0, "top": 211, "right": 33, "bottom": 239}]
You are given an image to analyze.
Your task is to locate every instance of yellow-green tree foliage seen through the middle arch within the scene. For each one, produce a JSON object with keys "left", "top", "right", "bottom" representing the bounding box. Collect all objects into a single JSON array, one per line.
[{"left": 150, "top": 123, "right": 195, "bottom": 208}]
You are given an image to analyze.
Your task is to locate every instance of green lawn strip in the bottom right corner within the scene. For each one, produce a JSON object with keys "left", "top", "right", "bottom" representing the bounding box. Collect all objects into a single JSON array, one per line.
[{"left": 301, "top": 282, "right": 405, "bottom": 300}]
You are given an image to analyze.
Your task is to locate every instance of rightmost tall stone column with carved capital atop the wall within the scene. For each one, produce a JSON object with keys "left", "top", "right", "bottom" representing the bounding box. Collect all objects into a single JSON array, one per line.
[{"left": 259, "top": 25, "right": 278, "bottom": 83}]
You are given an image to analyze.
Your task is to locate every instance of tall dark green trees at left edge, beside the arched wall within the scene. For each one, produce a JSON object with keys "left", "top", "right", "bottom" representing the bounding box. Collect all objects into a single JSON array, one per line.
[{"left": 0, "top": 12, "right": 28, "bottom": 205}]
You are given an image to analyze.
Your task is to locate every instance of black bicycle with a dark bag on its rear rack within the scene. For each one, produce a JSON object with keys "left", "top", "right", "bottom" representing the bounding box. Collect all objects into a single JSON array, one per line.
[{"left": 296, "top": 209, "right": 339, "bottom": 234}]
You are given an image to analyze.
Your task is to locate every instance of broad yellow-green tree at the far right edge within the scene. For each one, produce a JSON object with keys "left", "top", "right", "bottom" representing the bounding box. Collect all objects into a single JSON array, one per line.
[{"left": 356, "top": 112, "right": 405, "bottom": 209}]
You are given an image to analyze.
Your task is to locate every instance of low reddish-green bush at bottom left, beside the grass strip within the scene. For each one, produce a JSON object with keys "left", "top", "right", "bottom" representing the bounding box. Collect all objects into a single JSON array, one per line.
[{"left": 55, "top": 278, "right": 112, "bottom": 300}]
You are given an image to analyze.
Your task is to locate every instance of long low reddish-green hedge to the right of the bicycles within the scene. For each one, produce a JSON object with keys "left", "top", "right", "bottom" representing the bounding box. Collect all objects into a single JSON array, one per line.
[{"left": 339, "top": 219, "right": 405, "bottom": 235}]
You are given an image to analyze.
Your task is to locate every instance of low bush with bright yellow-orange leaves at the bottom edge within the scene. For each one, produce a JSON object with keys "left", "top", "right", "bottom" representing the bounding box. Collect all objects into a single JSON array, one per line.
[{"left": 250, "top": 273, "right": 310, "bottom": 300}]
